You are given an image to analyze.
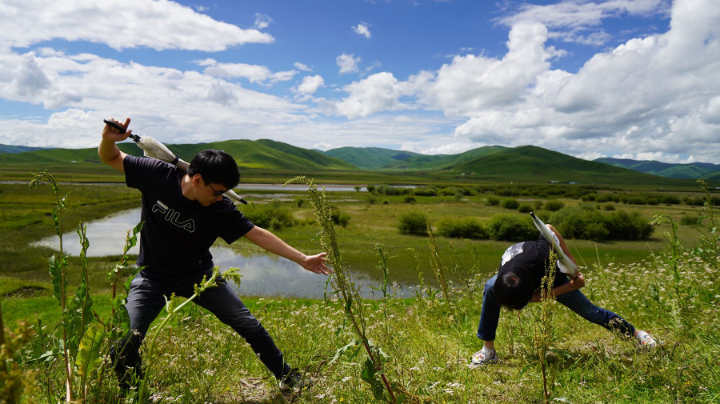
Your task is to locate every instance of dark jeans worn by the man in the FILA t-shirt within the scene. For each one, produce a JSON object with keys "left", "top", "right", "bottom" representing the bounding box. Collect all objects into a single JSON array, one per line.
[{"left": 111, "top": 270, "right": 290, "bottom": 383}]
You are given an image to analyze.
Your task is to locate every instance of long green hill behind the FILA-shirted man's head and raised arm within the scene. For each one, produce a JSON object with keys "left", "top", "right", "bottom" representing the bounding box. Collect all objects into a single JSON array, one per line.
[{"left": 0, "top": 140, "right": 357, "bottom": 170}]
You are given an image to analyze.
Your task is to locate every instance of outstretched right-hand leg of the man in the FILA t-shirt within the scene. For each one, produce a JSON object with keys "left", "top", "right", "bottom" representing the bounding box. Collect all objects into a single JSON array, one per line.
[{"left": 195, "top": 281, "right": 290, "bottom": 380}]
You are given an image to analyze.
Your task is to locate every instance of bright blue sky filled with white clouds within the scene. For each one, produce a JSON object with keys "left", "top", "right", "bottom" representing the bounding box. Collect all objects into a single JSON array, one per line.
[{"left": 0, "top": 0, "right": 720, "bottom": 163}]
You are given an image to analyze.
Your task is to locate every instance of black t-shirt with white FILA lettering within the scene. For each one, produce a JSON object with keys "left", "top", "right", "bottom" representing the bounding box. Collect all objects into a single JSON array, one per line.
[{"left": 123, "top": 156, "right": 255, "bottom": 280}]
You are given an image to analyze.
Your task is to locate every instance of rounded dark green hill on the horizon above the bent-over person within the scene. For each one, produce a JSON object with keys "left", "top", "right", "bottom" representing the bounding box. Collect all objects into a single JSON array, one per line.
[{"left": 448, "top": 146, "right": 686, "bottom": 185}]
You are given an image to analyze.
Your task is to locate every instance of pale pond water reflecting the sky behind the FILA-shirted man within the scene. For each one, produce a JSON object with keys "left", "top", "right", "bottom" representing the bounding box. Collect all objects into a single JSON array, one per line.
[{"left": 31, "top": 208, "right": 413, "bottom": 299}]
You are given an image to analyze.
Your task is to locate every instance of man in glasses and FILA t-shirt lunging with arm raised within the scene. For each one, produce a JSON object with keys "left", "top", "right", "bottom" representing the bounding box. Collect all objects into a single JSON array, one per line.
[{"left": 98, "top": 118, "right": 331, "bottom": 390}]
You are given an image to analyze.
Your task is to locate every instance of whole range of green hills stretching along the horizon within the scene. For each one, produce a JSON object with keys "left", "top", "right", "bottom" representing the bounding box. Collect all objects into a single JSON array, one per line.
[{"left": 0, "top": 139, "right": 720, "bottom": 185}]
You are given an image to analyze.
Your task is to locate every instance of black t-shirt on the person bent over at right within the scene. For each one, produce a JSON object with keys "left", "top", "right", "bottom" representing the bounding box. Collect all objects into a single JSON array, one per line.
[{"left": 498, "top": 234, "right": 565, "bottom": 290}]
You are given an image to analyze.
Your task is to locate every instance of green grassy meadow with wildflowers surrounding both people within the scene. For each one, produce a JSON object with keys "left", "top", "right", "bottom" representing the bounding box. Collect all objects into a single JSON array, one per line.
[{"left": 0, "top": 141, "right": 720, "bottom": 403}]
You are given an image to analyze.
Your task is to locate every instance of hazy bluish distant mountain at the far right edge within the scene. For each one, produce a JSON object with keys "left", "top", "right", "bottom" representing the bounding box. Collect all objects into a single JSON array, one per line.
[{"left": 595, "top": 158, "right": 720, "bottom": 180}]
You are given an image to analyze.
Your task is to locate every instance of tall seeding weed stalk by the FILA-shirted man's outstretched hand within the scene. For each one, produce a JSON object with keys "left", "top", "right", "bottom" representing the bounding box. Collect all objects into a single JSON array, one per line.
[{"left": 285, "top": 176, "right": 396, "bottom": 403}]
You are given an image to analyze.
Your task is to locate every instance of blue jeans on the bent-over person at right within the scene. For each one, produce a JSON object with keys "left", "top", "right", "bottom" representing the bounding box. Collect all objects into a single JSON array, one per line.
[{"left": 477, "top": 275, "right": 635, "bottom": 341}]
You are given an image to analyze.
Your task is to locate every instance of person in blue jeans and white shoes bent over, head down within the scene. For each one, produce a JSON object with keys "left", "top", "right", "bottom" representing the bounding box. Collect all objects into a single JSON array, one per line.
[{"left": 471, "top": 225, "right": 657, "bottom": 367}]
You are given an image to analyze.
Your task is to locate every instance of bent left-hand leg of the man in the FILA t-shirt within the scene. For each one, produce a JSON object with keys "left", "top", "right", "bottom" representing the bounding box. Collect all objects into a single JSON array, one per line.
[{"left": 110, "top": 273, "right": 165, "bottom": 385}]
